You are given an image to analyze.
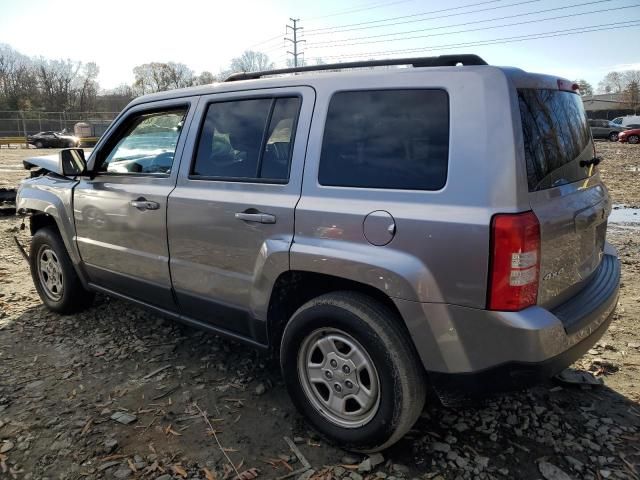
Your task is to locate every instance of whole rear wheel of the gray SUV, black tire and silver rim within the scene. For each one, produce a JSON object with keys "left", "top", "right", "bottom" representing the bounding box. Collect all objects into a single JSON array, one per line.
[{"left": 280, "top": 292, "right": 426, "bottom": 452}]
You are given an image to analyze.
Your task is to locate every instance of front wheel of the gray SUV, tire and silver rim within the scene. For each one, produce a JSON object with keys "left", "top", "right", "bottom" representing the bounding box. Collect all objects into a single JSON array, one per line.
[{"left": 29, "top": 227, "right": 95, "bottom": 314}]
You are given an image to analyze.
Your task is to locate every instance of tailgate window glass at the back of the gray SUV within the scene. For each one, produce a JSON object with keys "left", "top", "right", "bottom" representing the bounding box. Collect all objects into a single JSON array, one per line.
[{"left": 518, "top": 89, "right": 594, "bottom": 192}]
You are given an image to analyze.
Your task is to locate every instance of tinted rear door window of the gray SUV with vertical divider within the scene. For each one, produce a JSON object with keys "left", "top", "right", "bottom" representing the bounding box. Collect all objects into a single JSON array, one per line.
[{"left": 192, "top": 97, "right": 300, "bottom": 182}]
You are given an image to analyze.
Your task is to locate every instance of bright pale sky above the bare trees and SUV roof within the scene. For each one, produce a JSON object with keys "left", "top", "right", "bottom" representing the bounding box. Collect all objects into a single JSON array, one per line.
[{"left": 0, "top": 0, "right": 640, "bottom": 89}]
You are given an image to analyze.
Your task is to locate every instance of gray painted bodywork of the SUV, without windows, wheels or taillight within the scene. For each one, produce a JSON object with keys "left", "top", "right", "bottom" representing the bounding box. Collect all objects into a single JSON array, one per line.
[{"left": 18, "top": 66, "right": 615, "bottom": 373}]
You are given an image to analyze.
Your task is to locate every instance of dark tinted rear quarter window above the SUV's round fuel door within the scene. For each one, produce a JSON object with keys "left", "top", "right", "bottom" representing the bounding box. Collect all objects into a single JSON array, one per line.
[{"left": 318, "top": 89, "right": 449, "bottom": 190}]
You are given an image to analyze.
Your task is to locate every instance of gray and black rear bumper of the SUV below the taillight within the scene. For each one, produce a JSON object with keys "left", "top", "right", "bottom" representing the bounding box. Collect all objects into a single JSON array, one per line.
[{"left": 396, "top": 251, "right": 620, "bottom": 394}]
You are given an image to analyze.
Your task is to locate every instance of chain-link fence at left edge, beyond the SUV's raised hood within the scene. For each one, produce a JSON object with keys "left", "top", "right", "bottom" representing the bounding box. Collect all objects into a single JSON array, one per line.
[{"left": 0, "top": 110, "right": 119, "bottom": 137}]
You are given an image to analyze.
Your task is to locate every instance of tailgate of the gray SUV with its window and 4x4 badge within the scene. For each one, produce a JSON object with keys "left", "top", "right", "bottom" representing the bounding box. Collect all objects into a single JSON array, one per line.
[{"left": 518, "top": 88, "right": 611, "bottom": 308}]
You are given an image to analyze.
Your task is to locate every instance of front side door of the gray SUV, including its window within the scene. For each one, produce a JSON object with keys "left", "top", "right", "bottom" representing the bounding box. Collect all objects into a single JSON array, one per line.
[{"left": 74, "top": 98, "right": 197, "bottom": 311}]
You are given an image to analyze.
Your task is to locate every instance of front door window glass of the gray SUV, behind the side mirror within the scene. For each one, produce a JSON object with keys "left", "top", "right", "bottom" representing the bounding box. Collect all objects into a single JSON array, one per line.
[{"left": 99, "top": 107, "right": 187, "bottom": 175}]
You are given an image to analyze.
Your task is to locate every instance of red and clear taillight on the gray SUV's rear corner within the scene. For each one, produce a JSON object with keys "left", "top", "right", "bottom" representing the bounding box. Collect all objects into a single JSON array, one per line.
[{"left": 488, "top": 212, "right": 540, "bottom": 311}]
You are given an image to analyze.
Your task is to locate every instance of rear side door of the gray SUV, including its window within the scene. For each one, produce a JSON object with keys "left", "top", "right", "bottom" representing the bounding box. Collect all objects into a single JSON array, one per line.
[{"left": 167, "top": 87, "right": 315, "bottom": 345}]
